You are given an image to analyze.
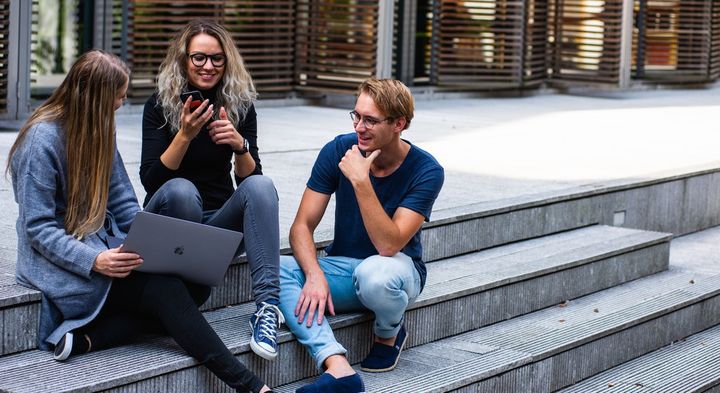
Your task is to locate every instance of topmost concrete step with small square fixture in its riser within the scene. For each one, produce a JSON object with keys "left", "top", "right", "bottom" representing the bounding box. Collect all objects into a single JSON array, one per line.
[{"left": 0, "top": 161, "right": 720, "bottom": 356}]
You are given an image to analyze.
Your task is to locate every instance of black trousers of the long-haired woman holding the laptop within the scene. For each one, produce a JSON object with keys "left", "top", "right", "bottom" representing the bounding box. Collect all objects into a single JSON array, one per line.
[{"left": 76, "top": 272, "right": 264, "bottom": 392}]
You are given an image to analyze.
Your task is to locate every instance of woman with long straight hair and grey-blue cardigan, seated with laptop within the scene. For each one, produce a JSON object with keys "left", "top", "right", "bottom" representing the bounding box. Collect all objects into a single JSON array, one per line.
[{"left": 8, "top": 50, "right": 270, "bottom": 392}]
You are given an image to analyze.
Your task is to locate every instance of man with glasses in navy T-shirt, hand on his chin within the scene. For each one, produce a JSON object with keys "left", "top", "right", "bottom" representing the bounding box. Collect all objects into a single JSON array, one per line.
[{"left": 280, "top": 79, "right": 444, "bottom": 393}]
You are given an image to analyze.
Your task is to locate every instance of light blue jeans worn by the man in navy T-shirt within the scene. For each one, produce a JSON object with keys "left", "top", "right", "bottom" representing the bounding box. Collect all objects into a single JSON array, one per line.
[{"left": 280, "top": 253, "right": 420, "bottom": 369}]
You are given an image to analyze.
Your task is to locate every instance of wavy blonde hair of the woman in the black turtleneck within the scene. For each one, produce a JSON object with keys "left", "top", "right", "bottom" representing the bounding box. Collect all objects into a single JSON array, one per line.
[{"left": 157, "top": 20, "right": 257, "bottom": 134}]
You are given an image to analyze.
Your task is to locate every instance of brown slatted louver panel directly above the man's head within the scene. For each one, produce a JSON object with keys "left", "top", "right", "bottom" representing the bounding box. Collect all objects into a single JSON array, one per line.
[{"left": 296, "top": 0, "right": 378, "bottom": 92}]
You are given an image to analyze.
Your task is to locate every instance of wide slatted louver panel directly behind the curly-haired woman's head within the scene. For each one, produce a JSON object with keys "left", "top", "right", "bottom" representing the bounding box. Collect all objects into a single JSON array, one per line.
[{"left": 122, "top": 0, "right": 295, "bottom": 98}]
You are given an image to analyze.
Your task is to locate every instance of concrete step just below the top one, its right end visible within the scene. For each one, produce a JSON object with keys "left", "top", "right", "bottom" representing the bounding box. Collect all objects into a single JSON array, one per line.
[{"left": 0, "top": 226, "right": 670, "bottom": 392}]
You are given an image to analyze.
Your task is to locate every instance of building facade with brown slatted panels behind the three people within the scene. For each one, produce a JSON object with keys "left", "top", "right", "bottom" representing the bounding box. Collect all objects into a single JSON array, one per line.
[{"left": 0, "top": 0, "right": 720, "bottom": 119}]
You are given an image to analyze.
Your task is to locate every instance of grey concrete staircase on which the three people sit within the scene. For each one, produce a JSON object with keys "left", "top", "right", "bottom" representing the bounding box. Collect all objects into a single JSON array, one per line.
[{"left": 0, "top": 167, "right": 720, "bottom": 393}]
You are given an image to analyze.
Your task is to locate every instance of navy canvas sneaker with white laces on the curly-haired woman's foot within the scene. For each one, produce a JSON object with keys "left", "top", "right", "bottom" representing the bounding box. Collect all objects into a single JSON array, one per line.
[{"left": 250, "top": 302, "right": 285, "bottom": 360}]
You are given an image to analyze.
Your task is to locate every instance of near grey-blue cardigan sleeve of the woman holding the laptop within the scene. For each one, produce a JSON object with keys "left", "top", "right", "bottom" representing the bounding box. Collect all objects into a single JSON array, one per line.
[{"left": 13, "top": 127, "right": 100, "bottom": 278}]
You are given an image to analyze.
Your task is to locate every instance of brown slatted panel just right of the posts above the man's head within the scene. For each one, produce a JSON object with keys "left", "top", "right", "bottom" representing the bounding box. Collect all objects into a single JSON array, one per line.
[{"left": 436, "top": 0, "right": 524, "bottom": 89}]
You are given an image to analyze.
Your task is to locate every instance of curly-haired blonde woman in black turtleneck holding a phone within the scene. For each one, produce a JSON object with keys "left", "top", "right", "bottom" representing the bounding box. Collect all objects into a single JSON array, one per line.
[{"left": 140, "top": 20, "right": 283, "bottom": 360}]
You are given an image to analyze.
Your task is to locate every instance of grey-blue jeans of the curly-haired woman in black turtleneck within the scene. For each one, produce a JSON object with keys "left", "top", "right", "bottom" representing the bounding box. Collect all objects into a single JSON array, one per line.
[{"left": 145, "top": 175, "right": 280, "bottom": 305}]
